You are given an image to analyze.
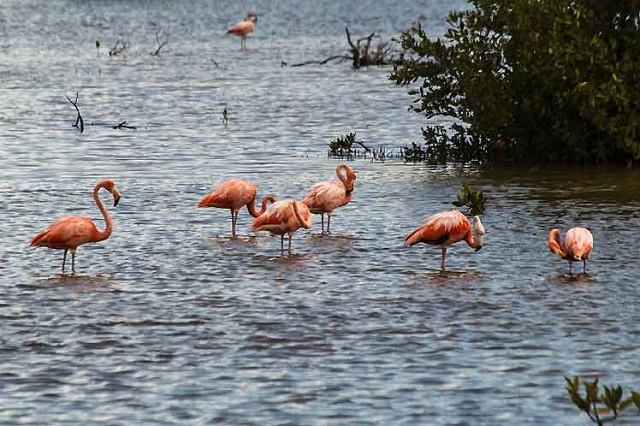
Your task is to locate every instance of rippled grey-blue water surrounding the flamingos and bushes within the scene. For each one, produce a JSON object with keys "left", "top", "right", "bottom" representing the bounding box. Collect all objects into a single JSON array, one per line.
[{"left": 0, "top": 0, "right": 640, "bottom": 425}]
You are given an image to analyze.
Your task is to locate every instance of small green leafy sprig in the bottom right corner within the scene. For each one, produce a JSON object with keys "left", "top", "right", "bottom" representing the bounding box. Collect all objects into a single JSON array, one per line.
[{"left": 564, "top": 376, "right": 640, "bottom": 426}]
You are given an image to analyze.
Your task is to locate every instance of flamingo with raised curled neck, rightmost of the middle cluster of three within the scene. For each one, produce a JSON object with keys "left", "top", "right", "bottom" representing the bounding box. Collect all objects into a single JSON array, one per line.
[{"left": 302, "top": 164, "right": 356, "bottom": 233}]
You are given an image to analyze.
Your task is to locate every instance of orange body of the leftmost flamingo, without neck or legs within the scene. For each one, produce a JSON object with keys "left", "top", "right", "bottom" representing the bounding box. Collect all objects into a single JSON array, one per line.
[{"left": 31, "top": 216, "right": 99, "bottom": 249}]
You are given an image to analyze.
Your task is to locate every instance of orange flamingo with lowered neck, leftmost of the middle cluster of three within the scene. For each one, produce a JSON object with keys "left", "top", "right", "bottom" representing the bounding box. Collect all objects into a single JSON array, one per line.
[{"left": 198, "top": 179, "right": 275, "bottom": 238}]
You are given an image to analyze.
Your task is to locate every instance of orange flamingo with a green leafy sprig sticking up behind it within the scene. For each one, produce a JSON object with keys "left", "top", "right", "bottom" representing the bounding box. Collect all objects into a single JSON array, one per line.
[{"left": 404, "top": 210, "right": 485, "bottom": 272}]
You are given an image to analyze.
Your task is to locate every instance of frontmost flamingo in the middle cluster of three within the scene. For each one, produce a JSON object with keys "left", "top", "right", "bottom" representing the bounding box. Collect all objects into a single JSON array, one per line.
[{"left": 251, "top": 200, "right": 312, "bottom": 255}]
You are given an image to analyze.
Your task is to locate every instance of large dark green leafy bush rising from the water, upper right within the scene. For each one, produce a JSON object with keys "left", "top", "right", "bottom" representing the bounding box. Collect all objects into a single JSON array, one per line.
[{"left": 390, "top": 0, "right": 640, "bottom": 164}]
